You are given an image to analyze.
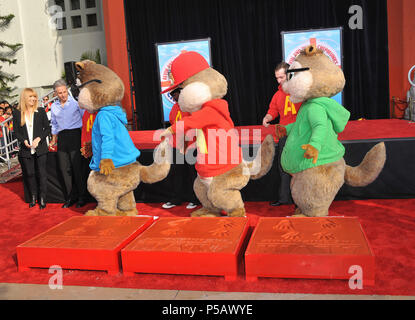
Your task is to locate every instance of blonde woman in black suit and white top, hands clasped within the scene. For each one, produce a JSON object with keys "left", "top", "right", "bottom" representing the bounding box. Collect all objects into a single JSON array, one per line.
[{"left": 13, "top": 88, "right": 50, "bottom": 209}]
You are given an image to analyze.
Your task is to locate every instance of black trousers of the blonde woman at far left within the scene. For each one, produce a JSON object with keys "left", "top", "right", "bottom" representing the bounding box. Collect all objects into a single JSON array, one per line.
[{"left": 19, "top": 153, "right": 48, "bottom": 199}]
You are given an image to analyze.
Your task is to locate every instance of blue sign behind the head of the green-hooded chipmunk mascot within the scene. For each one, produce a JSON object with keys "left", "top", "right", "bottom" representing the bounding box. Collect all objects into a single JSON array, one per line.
[{"left": 281, "top": 28, "right": 343, "bottom": 104}]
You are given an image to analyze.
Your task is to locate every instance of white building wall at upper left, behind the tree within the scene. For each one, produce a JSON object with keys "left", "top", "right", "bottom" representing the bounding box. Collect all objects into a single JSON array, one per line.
[{"left": 0, "top": 0, "right": 106, "bottom": 102}]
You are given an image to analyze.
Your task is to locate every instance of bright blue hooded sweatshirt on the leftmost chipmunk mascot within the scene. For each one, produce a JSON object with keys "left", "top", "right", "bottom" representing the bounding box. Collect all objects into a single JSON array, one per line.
[{"left": 89, "top": 106, "right": 140, "bottom": 171}]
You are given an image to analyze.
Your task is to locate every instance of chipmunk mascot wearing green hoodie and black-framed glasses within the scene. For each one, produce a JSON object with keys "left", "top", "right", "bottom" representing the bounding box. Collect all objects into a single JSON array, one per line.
[{"left": 276, "top": 45, "right": 386, "bottom": 217}]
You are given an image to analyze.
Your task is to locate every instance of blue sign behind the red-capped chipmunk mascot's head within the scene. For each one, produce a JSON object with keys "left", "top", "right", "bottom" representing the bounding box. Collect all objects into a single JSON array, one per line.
[{"left": 156, "top": 38, "right": 212, "bottom": 121}]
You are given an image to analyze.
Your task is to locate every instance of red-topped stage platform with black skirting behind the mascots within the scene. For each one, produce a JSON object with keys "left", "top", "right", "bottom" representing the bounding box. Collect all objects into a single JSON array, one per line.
[{"left": 25, "top": 119, "right": 415, "bottom": 203}]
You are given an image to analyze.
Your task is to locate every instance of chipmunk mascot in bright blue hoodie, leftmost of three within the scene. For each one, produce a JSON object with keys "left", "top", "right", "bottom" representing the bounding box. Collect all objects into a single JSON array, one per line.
[{"left": 75, "top": 60, "right": 170, "bottom": 216}]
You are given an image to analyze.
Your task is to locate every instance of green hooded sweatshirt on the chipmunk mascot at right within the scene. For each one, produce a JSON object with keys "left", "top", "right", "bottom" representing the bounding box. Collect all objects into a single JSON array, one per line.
[{"left": 281, "top": 97, "right": 350, "bottom": 173}]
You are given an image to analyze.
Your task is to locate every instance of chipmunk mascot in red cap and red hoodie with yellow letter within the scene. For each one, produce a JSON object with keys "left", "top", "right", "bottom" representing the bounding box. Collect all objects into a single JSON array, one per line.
[{"left": 161, "top": 51, "right": 275, "bottom": 217}]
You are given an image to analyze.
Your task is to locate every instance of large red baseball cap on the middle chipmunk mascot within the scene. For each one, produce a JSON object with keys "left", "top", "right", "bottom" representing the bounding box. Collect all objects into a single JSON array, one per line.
[{"left": 161, "top": 51, "right": 210, "bottom": 93}]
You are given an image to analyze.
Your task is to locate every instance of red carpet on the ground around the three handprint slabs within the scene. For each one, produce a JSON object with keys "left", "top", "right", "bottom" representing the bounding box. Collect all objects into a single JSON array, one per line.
[{"left": 0, "top": 176, "right": 415, "bottom": 296}]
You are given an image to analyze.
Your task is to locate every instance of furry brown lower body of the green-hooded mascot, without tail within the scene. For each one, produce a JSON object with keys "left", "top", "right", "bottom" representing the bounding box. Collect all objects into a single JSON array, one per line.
[{"left": 291, "top": 159, "right": 346, "bottom": 217}]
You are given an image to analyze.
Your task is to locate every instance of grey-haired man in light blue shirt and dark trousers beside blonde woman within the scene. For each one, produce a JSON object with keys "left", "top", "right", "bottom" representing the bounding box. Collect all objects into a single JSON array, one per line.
[{"left": 50, "top": 80, "right": 87, "bottom": 208}]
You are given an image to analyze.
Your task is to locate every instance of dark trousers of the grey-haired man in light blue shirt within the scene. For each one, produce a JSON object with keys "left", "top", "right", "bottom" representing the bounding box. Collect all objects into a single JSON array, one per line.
[{"left": 56, "top": 129, "right": 88, "bottom": 200}]
